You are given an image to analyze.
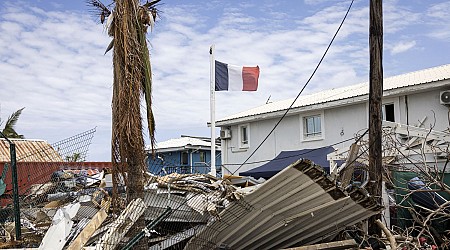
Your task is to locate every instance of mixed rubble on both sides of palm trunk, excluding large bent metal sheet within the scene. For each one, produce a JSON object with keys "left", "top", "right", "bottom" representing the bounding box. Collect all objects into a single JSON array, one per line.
[{"left": 0, "top": 169, "right": 243, "bottom": 249}]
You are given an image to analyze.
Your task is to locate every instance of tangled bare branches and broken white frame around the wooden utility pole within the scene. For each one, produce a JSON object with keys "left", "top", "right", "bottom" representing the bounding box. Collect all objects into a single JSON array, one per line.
[{"left": 328, "top": 121, "right": 450, "bottom": 249}]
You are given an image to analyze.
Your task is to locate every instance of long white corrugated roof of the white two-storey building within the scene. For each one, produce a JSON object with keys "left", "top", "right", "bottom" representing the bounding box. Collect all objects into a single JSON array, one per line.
[{"left": 217, "top": 64, "right": 450, "bottom": 122}]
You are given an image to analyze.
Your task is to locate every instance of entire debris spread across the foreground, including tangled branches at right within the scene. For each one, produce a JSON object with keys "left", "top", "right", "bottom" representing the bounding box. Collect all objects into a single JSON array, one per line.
[{"left": 4, "top": 121, "right": 450, "bottom": 249}]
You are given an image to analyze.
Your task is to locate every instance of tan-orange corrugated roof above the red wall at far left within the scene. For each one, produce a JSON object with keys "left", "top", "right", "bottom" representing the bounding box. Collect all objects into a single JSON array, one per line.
[{"left": 0, "top": 139, "right": 63, "bottom": 162}]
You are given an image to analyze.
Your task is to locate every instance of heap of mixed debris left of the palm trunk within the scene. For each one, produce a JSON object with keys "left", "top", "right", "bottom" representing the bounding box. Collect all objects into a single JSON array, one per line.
[{"left": 0, "top": 169, "right": 111, "bottom": 249}]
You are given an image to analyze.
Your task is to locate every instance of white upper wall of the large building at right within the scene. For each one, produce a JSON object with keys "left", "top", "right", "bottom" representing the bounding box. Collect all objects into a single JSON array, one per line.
[{"left": 222, "top": 89, "right": 449, "bottom": 175}]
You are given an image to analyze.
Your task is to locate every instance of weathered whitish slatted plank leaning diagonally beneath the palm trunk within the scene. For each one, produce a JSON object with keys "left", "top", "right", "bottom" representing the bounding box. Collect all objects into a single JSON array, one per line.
[{"left": 95, "top": 198, "right": 147, "bottom": 250}]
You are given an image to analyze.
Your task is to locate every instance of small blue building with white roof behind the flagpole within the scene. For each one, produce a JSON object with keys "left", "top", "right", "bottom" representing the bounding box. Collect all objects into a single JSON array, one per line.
[{"left": 146, "top": 135, "right": 222, "bottom": 176}]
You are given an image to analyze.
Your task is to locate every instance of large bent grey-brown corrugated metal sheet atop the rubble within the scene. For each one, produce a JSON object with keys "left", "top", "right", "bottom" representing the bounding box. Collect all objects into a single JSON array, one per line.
[{"left": 186, "top": 160, "right": 382, "bottom": 250}]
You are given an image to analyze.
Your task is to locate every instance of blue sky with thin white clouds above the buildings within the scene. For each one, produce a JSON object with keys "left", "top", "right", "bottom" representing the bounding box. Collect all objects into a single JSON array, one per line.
[{"left": 0, "top": 0, "right": 450, "bottom": 161}]
